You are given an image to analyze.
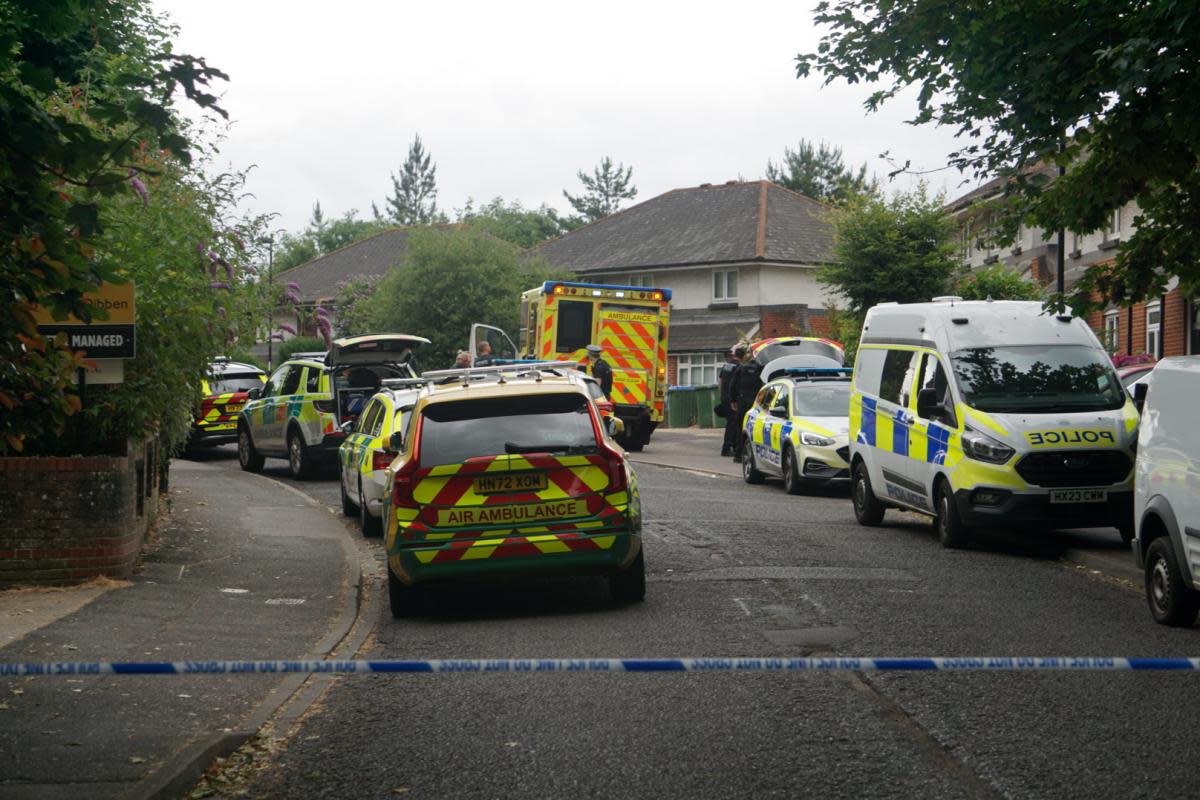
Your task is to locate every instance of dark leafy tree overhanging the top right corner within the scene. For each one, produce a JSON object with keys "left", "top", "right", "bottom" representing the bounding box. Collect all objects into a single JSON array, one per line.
[{"left": 797, "top": 0, "right": 1200, "bottom": 311}]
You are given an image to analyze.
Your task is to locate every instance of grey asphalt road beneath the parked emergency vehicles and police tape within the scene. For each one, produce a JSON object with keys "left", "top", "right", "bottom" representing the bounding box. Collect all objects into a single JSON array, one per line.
[{"left": 192, "top": 443, "right": 1200, "bottom": 798}]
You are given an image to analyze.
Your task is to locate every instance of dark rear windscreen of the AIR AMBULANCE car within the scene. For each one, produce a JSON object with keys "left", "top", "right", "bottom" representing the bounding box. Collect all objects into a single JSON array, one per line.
[{"left": 420, "top": 392, "right": 596, "bottom": 467}]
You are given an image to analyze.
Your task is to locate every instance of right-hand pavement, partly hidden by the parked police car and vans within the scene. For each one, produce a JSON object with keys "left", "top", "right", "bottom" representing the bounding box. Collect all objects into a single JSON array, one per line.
[{"left": 629, "top": 428, "right": 1144, "bottom": 590}]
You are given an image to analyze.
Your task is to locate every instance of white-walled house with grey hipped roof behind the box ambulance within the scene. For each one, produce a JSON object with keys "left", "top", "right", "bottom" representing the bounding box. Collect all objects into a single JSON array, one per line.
[{"left": 533, "top": 181, "right": 833, "bottom": 385}]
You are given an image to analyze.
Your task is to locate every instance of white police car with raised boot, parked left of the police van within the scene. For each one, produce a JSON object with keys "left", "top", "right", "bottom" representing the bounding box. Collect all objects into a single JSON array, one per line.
[{"left": 742, "top": 361, "right": 851, "bottom": 494}]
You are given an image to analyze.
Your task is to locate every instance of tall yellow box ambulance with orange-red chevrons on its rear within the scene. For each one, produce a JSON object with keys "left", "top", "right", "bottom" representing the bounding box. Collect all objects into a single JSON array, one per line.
[{"left": 470, "top": 281, "right": 671, "bottom": 451}]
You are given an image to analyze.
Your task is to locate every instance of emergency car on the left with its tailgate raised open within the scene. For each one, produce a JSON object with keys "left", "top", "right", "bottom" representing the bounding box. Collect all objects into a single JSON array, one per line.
[{"left": 238, "top": 333, "right": 430, "bottom": 480}]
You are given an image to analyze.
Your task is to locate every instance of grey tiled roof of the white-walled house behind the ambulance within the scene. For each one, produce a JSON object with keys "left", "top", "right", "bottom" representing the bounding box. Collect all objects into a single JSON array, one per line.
[{"left": 534, "top": 181, "right": 833, "bottom": 275}]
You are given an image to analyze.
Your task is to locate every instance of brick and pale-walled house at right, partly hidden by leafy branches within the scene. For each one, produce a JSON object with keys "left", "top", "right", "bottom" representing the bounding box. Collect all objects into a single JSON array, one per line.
[{"left": 946, "top": 179, "right": 1200, "bottom": 359}]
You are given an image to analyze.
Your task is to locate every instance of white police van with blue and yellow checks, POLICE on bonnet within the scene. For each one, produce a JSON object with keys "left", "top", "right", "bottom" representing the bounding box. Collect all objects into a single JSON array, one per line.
[{"left": 850, "top": 297, "right": 1138, "bottom": 547}]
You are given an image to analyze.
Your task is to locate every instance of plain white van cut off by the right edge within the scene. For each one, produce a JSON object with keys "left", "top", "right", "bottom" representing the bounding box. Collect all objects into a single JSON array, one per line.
[{"left": 1133, "top": 356, "right": 1200, "bottom": 627}]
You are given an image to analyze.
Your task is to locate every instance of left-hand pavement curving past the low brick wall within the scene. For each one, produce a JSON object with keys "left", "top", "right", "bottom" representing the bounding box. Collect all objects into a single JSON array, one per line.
[{"left": 0, "top": 461, "right": 361, "bottom": 800}]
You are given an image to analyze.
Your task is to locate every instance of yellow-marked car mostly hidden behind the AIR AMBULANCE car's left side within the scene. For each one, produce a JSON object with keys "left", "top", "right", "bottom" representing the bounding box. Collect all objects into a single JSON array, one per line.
[{"left": 337, "top": 378, "right": 425, "bottom": 536}]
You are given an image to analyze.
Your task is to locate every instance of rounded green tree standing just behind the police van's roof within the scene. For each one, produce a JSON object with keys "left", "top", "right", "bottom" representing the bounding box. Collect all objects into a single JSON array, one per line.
[{"left": 818, "top": 185, "right": 959, "bottom": 314}]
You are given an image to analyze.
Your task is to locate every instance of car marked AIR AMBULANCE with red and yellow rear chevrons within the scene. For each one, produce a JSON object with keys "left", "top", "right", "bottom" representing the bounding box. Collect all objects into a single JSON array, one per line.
[{"left": 384, "top": 362, "right": 646, "bottom": 616}]
